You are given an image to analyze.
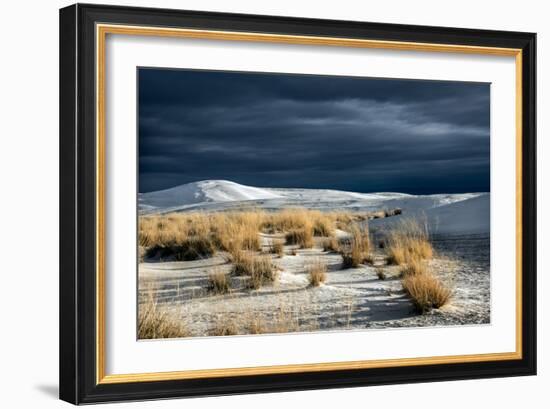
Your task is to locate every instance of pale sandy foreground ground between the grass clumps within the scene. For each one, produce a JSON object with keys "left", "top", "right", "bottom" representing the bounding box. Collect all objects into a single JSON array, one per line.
[{"left": 139, "top": 232, "right": 490, "bottom": 336}]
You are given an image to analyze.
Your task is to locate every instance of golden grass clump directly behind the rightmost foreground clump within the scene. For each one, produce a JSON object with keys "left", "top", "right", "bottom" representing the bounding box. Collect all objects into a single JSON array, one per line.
[{"left": 387, "top": 220, "right": 433, "bottom": 265}]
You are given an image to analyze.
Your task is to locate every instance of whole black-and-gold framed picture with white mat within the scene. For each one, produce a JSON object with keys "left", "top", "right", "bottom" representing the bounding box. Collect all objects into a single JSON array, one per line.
[{"left": 60, "top": 5, "right": 536, "bottom": 404}]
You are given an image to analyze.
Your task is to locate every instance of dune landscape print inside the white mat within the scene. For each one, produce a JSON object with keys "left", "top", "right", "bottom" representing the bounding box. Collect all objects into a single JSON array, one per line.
[{"left": 136, "top": 67, "right": 491, "bottom": 340}]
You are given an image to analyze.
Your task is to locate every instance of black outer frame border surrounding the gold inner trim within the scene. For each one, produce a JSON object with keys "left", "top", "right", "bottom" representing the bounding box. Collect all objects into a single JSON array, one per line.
[{"left": 59, "top": 4, "right": 536, "bottom": 404}]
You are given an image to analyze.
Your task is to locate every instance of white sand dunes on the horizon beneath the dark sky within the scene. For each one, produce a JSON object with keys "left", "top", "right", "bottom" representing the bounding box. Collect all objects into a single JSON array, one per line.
[{"left": 138, "top": 180, "right": 490, "bottom": 234}]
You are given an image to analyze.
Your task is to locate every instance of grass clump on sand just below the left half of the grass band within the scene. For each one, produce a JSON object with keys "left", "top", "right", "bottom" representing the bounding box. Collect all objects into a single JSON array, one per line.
[{"left": 231, "top": 251, "right": 278, "bottom": 290}]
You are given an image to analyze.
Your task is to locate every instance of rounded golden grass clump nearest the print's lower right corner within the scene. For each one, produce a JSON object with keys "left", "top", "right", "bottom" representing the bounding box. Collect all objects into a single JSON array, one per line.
[{"left": 401, "top": 273, "right": 451, "bottom": 313}]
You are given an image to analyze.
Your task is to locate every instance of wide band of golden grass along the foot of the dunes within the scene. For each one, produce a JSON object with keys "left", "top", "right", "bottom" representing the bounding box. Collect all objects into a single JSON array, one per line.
[{"left": 138, "top": 208, "right": 384, "bottom": 260}]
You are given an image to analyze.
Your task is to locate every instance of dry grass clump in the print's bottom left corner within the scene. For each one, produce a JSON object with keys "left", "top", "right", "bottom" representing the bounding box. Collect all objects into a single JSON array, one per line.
[{"left": 138, "top": 297, "right": 190, "bottom": 339}]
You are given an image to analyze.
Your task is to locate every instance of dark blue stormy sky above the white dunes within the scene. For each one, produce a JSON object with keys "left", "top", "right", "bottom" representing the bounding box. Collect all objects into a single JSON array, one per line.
[{"left": 138, "top": 68, "right": 490, "bottom": 194}]
